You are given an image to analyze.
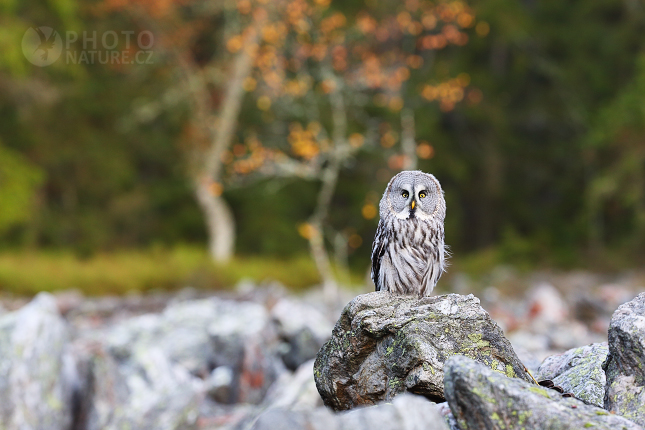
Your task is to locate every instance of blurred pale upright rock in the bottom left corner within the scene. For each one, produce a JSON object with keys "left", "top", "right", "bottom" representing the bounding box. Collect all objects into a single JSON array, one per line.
[{"left": 0, "top": 293, "right": 75, "bottom": 430}]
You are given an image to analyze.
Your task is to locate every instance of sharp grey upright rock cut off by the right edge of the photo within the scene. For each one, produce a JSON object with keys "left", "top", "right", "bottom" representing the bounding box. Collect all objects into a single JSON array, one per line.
[{"left": 603, "top": 293, "right": 645, "bottom": 425}]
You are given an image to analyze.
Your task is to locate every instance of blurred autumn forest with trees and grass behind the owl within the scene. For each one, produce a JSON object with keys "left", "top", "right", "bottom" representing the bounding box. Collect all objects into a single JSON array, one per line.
[{"left": 0, "top": 0, "right": 645, "bottom": 293}]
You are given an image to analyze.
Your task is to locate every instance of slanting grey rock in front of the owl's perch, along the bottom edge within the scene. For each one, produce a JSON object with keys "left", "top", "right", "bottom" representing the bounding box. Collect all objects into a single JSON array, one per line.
[{"left": 445, "top": 356, "right": 642, "bottom": 430}]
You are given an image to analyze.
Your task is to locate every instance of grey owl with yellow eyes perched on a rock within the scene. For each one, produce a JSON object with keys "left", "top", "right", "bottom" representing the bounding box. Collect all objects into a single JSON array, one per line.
[{"left": 371, "top": 170, "right": 448, "bottom": 297}]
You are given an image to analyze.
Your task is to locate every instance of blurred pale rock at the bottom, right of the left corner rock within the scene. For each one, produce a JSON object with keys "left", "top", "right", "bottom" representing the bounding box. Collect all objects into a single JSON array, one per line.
[{"left": 86, "top": 346, "right": 202, "bottom": 430}]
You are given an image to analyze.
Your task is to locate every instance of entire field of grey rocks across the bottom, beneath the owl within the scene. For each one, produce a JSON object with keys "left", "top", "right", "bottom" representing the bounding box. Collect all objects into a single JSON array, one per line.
[{"left": 0, "top": 273, "right": 645, "bottom": 430}]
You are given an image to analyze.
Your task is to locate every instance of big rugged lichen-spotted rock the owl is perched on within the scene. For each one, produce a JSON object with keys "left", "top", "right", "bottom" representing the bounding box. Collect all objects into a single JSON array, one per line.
[{"left": 314, "top": 292, "right": 529, "bottom": 410}]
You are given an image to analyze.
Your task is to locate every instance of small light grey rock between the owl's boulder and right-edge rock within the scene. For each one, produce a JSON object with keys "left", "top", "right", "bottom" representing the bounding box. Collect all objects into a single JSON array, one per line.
[{"left": 536, "top": 342, "right": 609, "bottom": 408}]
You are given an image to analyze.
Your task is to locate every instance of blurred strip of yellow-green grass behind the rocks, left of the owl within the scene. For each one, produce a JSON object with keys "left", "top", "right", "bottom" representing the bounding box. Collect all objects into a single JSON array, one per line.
[{"left": 0, "top": 246, "right": 319, "bottom": 295}]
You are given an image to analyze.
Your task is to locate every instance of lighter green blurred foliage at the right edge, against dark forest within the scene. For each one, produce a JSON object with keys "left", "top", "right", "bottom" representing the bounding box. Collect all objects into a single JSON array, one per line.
[{"left": 587, "top": 55, "right": 645, "bottom": 251}]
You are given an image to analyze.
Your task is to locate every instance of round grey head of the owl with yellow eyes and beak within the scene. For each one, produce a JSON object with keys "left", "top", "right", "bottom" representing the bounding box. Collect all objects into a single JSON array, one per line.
[{"left": 379, "top": 170, "right": 446, "bottom": 222}]
